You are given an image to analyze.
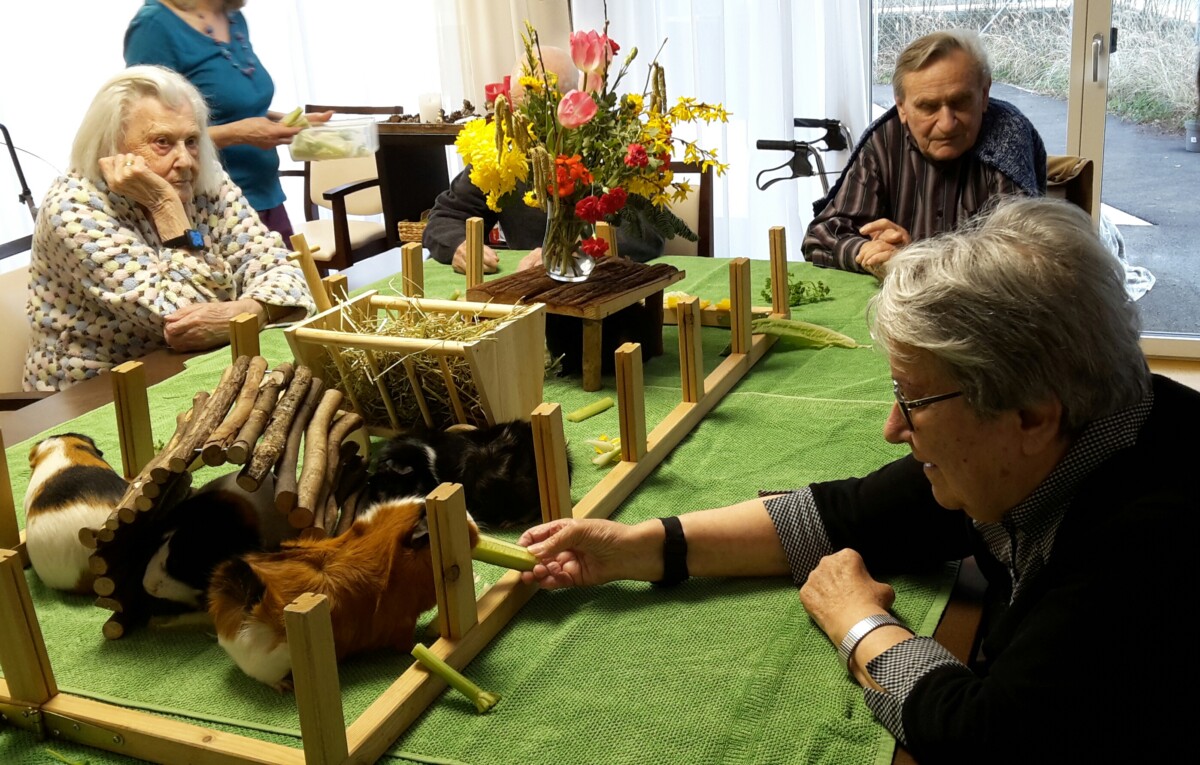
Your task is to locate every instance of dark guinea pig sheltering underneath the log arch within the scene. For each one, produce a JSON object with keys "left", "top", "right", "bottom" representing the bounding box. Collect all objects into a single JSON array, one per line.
[{"left": 142, "top": 471, "right": 300, "bottom": 608}]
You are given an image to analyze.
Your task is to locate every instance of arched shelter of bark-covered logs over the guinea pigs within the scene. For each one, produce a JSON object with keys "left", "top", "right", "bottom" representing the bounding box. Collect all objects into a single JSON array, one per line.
[{"left": 79, "top": 356, "right": 367, "bottom": 639}]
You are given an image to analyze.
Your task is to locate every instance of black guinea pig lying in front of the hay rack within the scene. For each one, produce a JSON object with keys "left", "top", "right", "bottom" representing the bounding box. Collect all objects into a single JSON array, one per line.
[{"left": 362, "top": 420, "right": 570, "bottom": 529}]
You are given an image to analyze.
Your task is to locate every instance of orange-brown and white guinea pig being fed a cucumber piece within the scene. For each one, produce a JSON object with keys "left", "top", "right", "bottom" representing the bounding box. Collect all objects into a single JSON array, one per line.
[{"left": 208, "top": 498, "right": 479, "bottom": 691}]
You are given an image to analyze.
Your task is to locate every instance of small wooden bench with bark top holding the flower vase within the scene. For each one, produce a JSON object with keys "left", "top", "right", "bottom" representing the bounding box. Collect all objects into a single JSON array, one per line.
[{"left": 467, "top": 258, "right": 688, "bottom": 391}]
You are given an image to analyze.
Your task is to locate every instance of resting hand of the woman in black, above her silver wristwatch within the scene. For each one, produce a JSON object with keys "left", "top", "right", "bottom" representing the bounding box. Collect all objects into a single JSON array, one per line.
[{"left": 800, "top": 549, "right": 896, "bottom": 645}]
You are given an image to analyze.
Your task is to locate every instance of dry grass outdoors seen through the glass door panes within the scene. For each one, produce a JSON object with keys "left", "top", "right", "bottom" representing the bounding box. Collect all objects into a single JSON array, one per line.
[{"left": 875, "top": 0, "right": 1198, "bottom": 133}]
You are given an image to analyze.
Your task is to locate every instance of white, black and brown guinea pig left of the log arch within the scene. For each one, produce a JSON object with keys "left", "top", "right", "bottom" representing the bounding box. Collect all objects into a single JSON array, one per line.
[{"left": 25, "top": 433, "right": 128, "bottom": 594}]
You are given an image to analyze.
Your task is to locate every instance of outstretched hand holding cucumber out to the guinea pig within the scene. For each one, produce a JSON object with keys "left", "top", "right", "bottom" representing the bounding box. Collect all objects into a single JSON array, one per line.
[{"left": 517, "top": 518, "right": 632, "bottom": 590}]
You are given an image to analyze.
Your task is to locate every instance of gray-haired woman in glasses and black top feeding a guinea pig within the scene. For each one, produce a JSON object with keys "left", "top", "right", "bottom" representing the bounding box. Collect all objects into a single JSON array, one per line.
[{"left": 520, "top": 198, "right": 1200, "bottom": 764}]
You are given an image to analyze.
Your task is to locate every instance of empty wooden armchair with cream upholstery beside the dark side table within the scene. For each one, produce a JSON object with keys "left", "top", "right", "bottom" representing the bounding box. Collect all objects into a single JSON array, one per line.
[{"left": 280, "top": 104, "right": 404, "bottom": 276}]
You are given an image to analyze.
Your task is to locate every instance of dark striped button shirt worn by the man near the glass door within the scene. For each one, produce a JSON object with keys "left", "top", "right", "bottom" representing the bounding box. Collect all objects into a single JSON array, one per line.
[{"left": 803, "top": 110, "right": 1021, "bottom": 272}]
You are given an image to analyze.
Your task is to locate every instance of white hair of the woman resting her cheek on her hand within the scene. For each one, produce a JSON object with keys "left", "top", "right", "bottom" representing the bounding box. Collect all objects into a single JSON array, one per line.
[{"left": 71, "top": 66, "right": 223, "bottom": 194}]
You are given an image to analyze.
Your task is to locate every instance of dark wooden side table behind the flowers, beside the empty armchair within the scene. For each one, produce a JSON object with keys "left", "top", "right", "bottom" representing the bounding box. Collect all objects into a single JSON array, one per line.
[{"left": 376, "top": 122, "right": 462, "bottom": 247}]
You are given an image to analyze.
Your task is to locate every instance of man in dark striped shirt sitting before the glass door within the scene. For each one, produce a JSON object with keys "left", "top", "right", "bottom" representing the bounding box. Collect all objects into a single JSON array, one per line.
[{"left": 802, "top": 30, "right": 1046, "bottom": 280}]
